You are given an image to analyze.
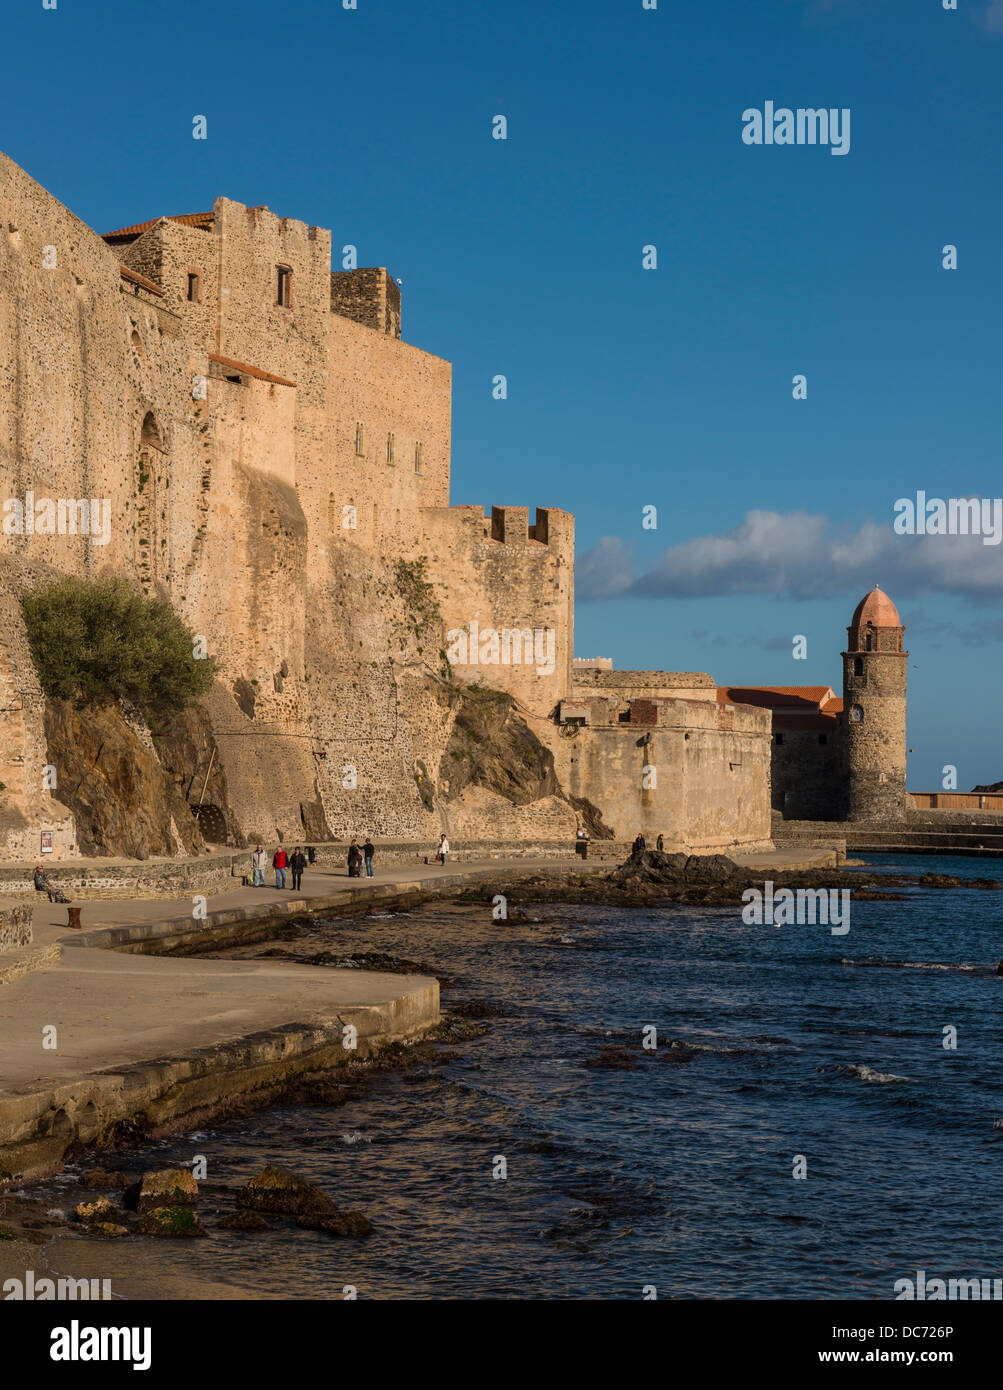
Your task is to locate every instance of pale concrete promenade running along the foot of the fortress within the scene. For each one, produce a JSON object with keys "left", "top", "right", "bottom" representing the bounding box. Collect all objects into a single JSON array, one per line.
[{"left": 0, "top": 849, "right": 834, "bottom": 1179}]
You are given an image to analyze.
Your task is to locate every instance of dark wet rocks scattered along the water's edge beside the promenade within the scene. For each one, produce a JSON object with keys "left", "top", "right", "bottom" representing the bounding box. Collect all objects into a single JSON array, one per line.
[{"left": 0, "top": 851, "right": 1003, "bottom": 1295}]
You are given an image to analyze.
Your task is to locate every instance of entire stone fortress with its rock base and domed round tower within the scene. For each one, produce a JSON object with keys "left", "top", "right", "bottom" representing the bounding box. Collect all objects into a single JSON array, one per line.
[{"left": 0, "top": 156, "right": 906, "bottom": 859}]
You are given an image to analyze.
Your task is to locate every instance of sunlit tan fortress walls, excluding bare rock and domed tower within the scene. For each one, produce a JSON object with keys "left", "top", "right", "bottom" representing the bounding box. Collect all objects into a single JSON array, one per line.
[{"left": 0, "top": 157, "right": 768, "bottom": 858}]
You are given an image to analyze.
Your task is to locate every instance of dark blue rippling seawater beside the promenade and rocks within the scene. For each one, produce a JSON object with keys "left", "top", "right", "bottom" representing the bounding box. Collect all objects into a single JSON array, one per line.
[{"left": 35, "top": 855, "right": 1003, "bottom": 1300}]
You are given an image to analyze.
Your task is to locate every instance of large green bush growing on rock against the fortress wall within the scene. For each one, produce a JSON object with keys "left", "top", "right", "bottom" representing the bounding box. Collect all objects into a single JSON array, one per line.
[{"left": 21, "top": 577, "right": 215, "bottom": 716}]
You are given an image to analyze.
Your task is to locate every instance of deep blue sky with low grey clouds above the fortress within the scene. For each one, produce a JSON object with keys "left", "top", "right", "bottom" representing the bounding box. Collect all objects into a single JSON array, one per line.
[{"left": 0, "top": 0, "right": 1003, "bottom": 788}]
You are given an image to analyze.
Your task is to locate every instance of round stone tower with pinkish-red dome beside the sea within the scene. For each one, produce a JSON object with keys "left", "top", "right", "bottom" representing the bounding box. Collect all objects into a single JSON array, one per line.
[{"left": 842, "top": 584, "right": 909, "bottom": 820}]
